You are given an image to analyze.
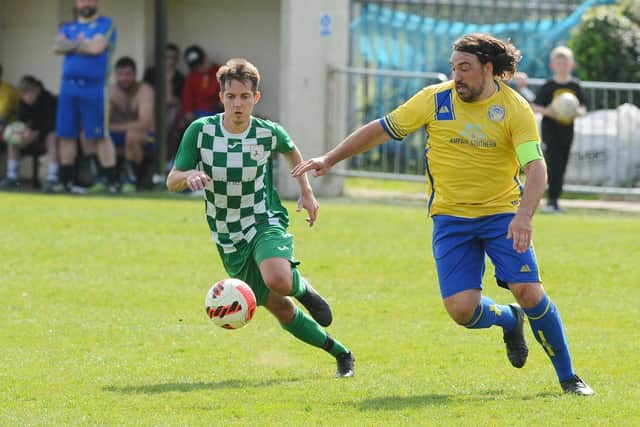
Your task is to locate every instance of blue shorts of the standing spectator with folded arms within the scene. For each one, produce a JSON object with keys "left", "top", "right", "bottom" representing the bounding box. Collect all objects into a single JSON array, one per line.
[{"left": 56, "top": 78, "right": 108, "bottom": 140}]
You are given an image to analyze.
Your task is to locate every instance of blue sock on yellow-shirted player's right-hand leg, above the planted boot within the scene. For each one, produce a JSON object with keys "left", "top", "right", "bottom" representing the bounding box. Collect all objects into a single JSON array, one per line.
[{"left": 524, "top": 295, "right": 575, "bottom": 381}]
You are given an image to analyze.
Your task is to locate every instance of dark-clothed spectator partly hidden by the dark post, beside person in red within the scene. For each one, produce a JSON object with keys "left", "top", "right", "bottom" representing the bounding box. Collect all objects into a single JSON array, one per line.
[{"left": 144, "top": 43, "right": 185, "bottom": 169}]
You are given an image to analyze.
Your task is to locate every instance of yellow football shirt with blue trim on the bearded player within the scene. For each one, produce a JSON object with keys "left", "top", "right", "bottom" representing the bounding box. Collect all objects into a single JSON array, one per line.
[{"left": 380, "top": 81, "right": 542, "bottom": 218}]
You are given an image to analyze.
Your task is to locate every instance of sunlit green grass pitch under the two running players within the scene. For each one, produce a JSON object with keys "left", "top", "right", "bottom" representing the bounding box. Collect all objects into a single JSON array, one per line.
[{"left": 0, "top": 193, "right": 640, "bottom": 426}]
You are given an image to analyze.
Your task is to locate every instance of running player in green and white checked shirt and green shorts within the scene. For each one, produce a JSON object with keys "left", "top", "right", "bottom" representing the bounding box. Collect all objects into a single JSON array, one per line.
[{"left": 167, "top": 59, "right": 354, "bottom": 378}]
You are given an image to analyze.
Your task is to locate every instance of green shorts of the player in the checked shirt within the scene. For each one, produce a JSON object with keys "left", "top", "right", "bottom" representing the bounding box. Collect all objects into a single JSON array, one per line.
[{"left": 218, "top": 225, "right": 300, "bottom": 305}]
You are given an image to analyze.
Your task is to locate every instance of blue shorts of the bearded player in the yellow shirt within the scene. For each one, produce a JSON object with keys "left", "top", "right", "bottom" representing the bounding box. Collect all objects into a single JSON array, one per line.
[{"left": 433, "top": 214, "right": 540, "bottom": 298}]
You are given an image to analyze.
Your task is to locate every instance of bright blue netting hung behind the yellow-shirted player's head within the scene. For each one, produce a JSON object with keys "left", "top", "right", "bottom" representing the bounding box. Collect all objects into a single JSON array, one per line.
[{"left": 350, "top": 0, "right": 616, "bottom": 77}]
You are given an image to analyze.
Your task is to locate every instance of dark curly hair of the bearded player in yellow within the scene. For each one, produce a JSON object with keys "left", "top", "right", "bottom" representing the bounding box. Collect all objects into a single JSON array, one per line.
[{"left": 453, "top": 33, "right": 522, "bottom": 80}]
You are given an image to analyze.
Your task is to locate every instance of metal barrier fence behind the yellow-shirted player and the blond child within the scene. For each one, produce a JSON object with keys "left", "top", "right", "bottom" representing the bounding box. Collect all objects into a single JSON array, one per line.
[{"left": 325, "top": 68, "right": 640, "bottom": 194}]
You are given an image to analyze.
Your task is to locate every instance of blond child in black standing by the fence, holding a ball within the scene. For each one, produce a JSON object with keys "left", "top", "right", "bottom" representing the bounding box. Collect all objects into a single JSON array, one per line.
[{"left": 532, "top": 46, "right": 587, "bottom": 213}]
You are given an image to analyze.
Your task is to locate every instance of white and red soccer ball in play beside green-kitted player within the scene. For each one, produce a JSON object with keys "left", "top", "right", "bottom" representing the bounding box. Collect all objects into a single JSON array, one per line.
[{"left": 204, "top": 279, "right": 256, "bottom": 329}]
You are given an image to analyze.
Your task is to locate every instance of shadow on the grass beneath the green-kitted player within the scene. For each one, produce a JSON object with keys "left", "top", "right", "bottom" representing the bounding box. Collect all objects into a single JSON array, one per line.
[{"left": 102, "top": 378, "right": 300, "bottom": 394}]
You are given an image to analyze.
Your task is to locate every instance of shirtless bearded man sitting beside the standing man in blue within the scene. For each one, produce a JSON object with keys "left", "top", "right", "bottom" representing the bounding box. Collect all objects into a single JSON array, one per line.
[{"left": 109, "top": 56, "right": 154, "bottom": 191}]
